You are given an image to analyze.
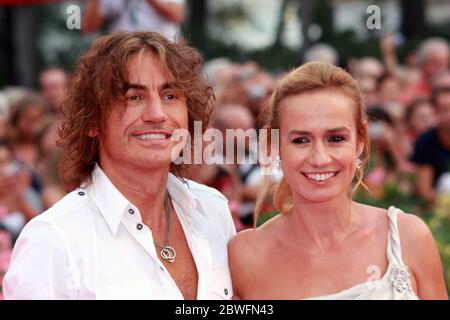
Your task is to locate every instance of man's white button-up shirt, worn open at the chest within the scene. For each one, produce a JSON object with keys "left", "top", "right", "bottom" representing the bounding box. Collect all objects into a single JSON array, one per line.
[{"left": 3, "top": 166, "right": 236, "bottom": 300}]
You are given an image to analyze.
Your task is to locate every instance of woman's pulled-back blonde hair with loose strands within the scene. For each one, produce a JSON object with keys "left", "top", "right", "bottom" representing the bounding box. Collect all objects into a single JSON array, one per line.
[{"left": 254, "top": 62, "right": 370, "bottom": 226}]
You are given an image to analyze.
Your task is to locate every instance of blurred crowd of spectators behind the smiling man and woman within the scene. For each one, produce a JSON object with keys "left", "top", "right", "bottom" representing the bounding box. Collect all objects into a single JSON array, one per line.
[{"left": 0, "top": 28, "right": 450, "bottom": 293}]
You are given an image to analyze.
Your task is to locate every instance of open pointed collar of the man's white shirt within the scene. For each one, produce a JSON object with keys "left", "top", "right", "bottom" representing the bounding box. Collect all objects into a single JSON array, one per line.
[{"left": 87, "top": 164, "right": 198, "bottom": 234}]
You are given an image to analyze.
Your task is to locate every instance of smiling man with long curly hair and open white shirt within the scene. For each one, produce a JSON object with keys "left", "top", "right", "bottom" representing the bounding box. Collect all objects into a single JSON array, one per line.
[{"left": 3, "top": 32, "right": 235, "bottom": 299}]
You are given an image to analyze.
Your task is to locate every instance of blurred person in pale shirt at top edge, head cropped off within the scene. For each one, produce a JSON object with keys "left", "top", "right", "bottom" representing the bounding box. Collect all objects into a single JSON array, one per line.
[{"left": 82, "top": 0, "right": 185, "bottom": 40}]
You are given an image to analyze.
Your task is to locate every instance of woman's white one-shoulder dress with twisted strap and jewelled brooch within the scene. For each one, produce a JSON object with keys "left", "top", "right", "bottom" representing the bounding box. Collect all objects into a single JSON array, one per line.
[{"left": 308, "top": 206, "right": 419, "bottom": 300}]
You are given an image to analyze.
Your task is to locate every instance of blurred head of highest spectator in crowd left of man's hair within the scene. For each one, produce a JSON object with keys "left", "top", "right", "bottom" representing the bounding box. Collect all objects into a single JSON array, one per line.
[{"left": 39, "top": 68, "right": 67, "bottom": 113}]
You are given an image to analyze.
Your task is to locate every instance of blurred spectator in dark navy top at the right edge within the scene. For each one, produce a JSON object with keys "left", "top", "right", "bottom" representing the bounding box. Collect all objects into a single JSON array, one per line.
[{"left": 411, "top": 87, "right": 450, "bottom": 202}]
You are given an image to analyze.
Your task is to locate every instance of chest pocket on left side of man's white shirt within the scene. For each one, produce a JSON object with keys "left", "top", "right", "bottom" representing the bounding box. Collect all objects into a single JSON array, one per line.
[{"left": 95, "top": 280, "right": 153, "bottom": 300}]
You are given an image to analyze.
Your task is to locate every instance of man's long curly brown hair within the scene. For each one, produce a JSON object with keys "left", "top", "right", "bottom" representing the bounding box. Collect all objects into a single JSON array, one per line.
[{"left": 58, "top": 32, "right": 214, "bottom": 191}]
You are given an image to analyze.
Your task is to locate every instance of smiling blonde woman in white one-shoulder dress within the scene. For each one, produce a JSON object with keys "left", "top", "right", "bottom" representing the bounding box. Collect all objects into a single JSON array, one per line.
[{"left": 229, "top": 62, "right": 448, "bottom": 299}]
